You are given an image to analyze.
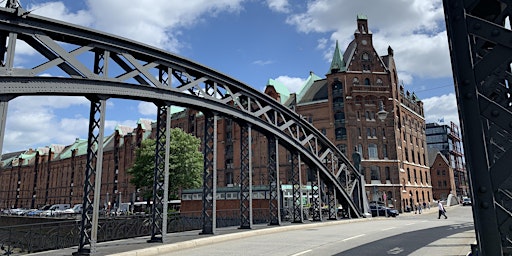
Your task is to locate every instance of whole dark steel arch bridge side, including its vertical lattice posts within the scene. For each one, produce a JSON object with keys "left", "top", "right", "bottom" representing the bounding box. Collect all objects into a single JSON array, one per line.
[{"left": 0, "top": 0, "right": 365, "bottom": 254}]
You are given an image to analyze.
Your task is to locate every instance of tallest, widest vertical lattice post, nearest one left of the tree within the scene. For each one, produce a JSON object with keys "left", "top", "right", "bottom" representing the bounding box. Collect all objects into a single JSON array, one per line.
[{"left": 73, "top": 98, "right": 106, "bottom": 255}]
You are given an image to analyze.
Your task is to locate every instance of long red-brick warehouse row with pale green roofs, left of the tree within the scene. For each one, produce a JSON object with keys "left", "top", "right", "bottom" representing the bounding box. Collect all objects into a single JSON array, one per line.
[{"left": 0, "top": 120, "right": 152, "bottom": 211}]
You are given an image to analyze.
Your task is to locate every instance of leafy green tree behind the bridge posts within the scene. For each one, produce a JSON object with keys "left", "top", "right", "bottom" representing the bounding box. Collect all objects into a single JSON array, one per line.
[{"left": 128, "top": 128, "right": 203, "bottom": 199}]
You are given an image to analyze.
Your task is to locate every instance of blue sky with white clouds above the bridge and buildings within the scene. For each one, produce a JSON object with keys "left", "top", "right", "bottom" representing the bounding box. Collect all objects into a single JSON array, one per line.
[{"left": 1, "top": 0, "right": 459, "bottom": 153}]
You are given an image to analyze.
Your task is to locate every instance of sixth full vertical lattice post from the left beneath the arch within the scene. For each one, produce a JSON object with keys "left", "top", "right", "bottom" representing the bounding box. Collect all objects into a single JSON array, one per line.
[{"left": 291, "top": 152, "right": 304, "bottom": 223}]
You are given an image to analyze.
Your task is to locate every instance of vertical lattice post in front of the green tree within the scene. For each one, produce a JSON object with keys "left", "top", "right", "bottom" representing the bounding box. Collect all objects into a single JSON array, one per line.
[{"left": 148, "top": 105, "right": 171, "bottom": 243}]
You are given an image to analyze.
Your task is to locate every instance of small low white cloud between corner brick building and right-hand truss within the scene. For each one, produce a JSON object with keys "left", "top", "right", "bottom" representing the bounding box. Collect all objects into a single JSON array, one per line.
[{"left": 423, "top": 93, "right": 460, "bottom": 126}]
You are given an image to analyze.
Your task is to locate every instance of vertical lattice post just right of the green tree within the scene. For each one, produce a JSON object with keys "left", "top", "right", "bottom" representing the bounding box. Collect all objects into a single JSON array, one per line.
[{"left": 201, "top": 112, "right": 217, "bottom": 234}]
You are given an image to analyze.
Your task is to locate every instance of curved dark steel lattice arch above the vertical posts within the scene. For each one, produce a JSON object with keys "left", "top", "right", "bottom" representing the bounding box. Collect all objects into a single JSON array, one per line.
[{"left": 0, "top": 6, "right": 364, "bottom": 254}]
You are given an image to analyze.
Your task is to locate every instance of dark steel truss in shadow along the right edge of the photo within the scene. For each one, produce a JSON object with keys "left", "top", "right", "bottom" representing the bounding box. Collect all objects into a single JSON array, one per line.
[{"left": 443, "top": 0, "right": 512, "bottom": 255}]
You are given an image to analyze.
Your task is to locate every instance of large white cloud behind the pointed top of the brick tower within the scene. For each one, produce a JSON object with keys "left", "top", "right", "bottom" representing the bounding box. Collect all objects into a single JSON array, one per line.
[{"left": 287, "top": 0, "right": 451, "bottom": 82}]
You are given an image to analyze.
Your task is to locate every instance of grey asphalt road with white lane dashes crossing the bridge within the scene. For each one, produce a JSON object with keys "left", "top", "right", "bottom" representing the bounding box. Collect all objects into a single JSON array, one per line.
[{"left": 160, "top": 206, "right": 475, "bottom": 256}]
